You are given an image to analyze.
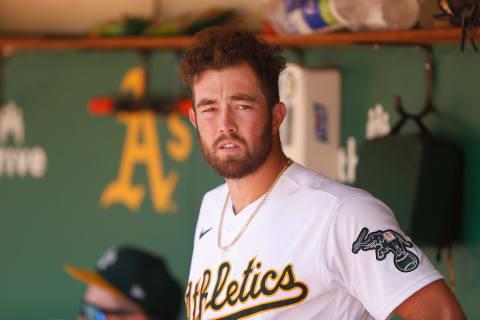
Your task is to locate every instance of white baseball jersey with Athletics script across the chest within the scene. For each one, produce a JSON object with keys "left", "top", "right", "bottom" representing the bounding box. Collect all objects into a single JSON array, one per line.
[{"left": 185, "top": 163, "right": 442, "bottom": 320}]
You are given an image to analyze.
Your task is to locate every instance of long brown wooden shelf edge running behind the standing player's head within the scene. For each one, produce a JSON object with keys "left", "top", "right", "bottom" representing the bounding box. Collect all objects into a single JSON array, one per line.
[{"left": 0, "top": 27, "right": 480, "bottom": 53}]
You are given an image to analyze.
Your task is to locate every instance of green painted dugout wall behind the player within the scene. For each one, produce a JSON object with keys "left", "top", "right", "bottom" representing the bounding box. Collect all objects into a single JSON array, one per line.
[{"left": 0, "top": 46, "right": 480, "bottom": 319}]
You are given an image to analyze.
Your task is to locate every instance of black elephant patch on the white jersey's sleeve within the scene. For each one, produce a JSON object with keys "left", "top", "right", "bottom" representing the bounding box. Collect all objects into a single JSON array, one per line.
[{"left": 352, "top": 227, "right": 419, "bottom": 272}]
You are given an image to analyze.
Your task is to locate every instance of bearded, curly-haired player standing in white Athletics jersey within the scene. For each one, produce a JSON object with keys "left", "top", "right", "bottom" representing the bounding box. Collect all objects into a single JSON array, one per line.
[{"left": 180, "top": 27, "right": 465, "bottom": 320}]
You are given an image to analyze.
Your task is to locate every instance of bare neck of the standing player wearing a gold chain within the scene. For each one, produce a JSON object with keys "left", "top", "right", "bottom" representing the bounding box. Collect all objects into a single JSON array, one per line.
[{"left": 225, "top": 148, "right": 288, "bottom": 213}]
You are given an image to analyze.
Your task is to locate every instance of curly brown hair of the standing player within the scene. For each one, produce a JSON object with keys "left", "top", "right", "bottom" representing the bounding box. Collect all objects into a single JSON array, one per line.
[{"left": 180, "top": 26, "right": 285, "bottom": 108}]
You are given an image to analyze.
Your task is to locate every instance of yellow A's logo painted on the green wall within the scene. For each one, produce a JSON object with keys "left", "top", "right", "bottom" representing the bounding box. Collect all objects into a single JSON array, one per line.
[{"left": 100, "top": 68, "right": 192, "bottom": 213}]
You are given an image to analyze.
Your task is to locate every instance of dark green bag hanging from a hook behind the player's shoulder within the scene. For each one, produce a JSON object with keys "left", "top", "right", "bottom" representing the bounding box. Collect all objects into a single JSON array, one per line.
[{"left": 355, "top": 134, "right": 463, "bottom": 248}]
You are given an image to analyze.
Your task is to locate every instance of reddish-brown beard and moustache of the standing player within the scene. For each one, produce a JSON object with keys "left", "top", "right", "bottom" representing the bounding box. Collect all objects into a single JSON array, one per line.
[{"left": 197, "top": 115, "right": 273, "bottom": 179}]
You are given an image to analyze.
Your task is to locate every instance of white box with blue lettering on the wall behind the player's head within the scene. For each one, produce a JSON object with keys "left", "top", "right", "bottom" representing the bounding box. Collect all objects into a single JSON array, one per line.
[{"left": 279, "top": 63, "right": 341, "bottom": 179}]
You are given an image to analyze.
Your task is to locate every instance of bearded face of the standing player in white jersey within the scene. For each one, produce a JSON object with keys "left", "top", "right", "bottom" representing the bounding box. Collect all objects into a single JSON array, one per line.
[{"left": 190, "top": 63, "right": 273, "bottom": 178}]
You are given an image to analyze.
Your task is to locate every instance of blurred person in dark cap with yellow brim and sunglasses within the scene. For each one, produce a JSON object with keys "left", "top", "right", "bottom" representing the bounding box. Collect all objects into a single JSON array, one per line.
[{"left": 65, "top": 246, "right": 182, "bottom": 320}]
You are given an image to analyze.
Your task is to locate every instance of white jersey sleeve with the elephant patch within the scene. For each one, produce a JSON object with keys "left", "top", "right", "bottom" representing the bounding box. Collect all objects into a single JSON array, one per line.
[{"left": 323, "top": 195, "right": 442, "bottom": 319}]
